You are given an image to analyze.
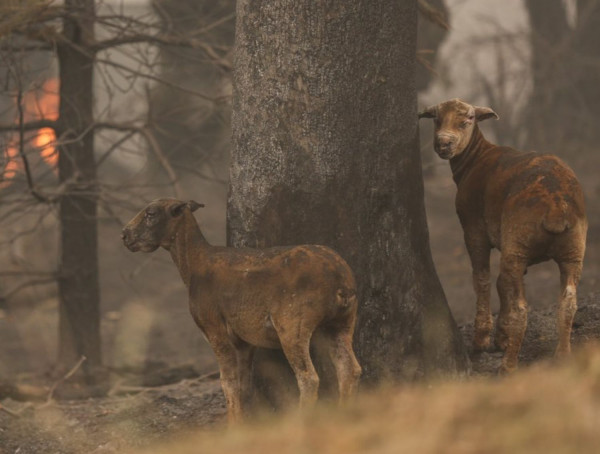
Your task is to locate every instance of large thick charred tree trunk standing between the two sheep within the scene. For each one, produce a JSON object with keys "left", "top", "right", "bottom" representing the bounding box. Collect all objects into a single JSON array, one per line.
[{"left": 227, "top": 0, "right": 468, "bottom": 394}]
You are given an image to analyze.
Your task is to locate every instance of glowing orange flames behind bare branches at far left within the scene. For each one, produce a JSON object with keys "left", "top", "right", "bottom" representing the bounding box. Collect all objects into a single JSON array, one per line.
[{"left": 0, "top": 78, "right": 59, "bottom": 188}]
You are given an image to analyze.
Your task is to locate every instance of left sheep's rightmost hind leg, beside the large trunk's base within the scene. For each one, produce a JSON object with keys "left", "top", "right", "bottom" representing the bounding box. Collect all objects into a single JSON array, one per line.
[{"left": 329, "top": 332, "right": 362, "bottom": 403}]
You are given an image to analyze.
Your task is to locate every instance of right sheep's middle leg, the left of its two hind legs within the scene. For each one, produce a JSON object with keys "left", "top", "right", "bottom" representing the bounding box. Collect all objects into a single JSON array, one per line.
[{"left": 497, "top": 254, "right": 527, "bottom": 372}]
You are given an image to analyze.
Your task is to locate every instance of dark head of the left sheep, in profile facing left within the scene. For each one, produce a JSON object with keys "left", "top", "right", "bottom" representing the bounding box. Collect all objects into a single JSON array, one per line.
[{"left": 121, "top": 199, "right": 204, "bottom": 252}]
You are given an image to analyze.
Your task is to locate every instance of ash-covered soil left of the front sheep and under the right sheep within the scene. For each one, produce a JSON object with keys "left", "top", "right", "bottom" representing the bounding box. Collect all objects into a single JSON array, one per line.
[{"left": 0, "top": 294, "right": 600, "bottom": 454}]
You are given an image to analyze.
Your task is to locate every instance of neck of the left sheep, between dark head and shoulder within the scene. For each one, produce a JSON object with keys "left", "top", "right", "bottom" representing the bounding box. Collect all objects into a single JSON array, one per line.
[{"left": 169, "top": 212, "right": 210, "bottom": 288}]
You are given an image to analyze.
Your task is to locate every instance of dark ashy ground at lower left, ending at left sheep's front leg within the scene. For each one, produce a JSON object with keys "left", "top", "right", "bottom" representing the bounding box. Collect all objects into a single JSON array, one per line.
[{"left": 0, "top": 378, "right": 226, "bottom": 454}]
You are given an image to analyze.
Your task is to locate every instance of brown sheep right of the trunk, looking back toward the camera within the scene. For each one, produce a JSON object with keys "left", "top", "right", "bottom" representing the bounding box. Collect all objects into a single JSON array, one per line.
[{"left": 419, "top": 99, "right": 587, "bottom": 373}]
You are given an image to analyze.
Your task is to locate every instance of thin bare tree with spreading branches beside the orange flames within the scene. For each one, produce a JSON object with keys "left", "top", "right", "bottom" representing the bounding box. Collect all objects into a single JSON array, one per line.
[{"left": 0, "top": 0, "right": 228, "bottom": 379}]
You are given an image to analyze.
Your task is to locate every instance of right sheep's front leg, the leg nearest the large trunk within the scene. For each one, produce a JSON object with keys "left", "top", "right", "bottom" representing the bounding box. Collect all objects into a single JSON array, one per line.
[{"left": 465, "top": 233, "right": 493, "bottom": 351}]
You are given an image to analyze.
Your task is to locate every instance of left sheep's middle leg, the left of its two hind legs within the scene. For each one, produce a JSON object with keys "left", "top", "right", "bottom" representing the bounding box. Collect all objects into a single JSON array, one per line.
[{"left": 274, "top": 323, "right": 319, "bottom": 408}]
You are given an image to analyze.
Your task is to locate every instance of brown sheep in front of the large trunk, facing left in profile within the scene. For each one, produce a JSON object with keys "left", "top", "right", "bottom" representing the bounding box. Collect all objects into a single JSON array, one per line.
[{"left": 121, "top": 199, "right": 361, "bottom": 423}]
